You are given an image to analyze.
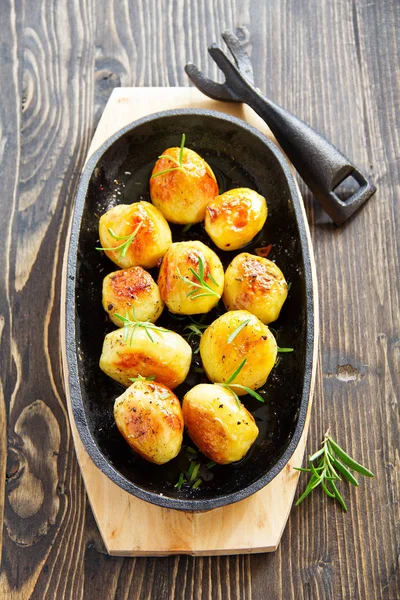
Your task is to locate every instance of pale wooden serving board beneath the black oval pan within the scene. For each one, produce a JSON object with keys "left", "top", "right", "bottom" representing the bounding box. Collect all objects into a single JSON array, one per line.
[{"left": 61, "top": 88, "right": 318, "bottom": 556}]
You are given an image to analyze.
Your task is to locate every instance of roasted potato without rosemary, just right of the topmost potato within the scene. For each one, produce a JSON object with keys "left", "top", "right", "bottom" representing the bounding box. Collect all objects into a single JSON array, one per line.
[{"left": 205, "top": 188, "right": 268, "bottom": 250}]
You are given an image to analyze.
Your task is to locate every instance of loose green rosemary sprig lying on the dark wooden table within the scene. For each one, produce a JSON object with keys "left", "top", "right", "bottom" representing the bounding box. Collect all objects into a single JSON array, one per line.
[{"left": 294, "top": 430, "right": 374, "bottom": 512}]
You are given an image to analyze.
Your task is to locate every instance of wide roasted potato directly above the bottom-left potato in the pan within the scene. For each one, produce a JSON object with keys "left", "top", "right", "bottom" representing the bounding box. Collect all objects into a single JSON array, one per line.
[{"left": 100, "top": 325, "right": 192, "bottom": 390}]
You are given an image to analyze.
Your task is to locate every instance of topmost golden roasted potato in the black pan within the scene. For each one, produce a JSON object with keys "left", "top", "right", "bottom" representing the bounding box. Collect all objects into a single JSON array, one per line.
[{"left": 150, "top": 148, "right": 218, "bottom": 225}]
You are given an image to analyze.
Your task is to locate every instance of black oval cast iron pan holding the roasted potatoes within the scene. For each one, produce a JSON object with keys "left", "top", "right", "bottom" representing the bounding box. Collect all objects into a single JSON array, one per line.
[{"left": 66, "top": 110, "right": 314, "bottom": 511}]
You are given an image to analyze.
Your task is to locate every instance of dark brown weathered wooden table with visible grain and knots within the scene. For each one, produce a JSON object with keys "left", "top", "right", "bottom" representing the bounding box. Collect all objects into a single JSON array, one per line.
[{"left": 0, "top": 0, "right": 400, "bottom": 600}]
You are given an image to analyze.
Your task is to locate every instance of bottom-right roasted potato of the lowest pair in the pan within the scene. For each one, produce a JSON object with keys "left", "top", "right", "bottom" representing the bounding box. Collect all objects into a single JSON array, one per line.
[{"left": 182, "top": 383, "right": 258, "bottom": 465}]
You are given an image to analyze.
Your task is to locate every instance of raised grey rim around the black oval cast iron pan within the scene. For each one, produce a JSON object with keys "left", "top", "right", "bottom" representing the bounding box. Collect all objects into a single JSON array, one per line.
[{"left": 63, "top": 109, "right": 316, "bottom": 512}]
